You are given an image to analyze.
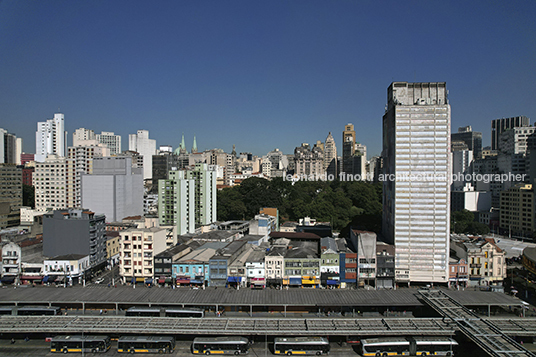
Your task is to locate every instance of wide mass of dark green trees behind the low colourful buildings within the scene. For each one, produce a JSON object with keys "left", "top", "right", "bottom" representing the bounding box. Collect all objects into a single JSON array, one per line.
[{"left": 218, "top": 177, "right": 382, "bottom": 231}]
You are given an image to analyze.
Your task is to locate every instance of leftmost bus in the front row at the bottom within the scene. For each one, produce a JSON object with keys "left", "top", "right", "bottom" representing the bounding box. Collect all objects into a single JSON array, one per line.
[{"left": 50, "top": 336, "right": 112, "bottom": 353}]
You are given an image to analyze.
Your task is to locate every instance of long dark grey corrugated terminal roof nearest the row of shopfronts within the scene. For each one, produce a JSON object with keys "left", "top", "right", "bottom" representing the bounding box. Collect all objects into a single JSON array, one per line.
[{"left": 0, "top": 286, "right": 521, "bottom": 307}]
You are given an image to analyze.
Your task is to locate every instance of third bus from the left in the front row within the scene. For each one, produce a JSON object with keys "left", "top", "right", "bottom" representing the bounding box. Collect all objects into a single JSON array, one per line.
[{"left": 192, "top": 336, "right": 250, "bottom": 355}]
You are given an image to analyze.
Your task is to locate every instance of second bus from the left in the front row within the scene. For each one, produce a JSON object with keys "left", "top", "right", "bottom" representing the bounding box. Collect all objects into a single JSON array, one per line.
[{"left": 117, "top": 336, "right": 175, "bottom": 353}]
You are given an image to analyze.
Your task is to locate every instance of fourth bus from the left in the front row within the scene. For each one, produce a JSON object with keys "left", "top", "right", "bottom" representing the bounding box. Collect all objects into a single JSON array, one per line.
[{"left": 274, "top": 337, "right": 330, "bottom": 356}]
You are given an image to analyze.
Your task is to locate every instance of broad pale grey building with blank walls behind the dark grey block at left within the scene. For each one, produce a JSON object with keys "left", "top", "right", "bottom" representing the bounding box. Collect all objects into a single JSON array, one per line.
[{"left": 80, "top": 156, "right": 143, "bottom": 222}]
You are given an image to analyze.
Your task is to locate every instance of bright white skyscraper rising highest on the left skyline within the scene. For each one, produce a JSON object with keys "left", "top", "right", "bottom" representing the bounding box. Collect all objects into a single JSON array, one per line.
[{"left": 35, "top": 113, "right": 67, "bottom": 162}]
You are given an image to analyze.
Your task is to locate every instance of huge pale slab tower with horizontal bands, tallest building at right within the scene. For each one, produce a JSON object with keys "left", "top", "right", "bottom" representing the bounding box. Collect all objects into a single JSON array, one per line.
[{"left": 382, "top": 82, "right": 452, "bottom": 284}]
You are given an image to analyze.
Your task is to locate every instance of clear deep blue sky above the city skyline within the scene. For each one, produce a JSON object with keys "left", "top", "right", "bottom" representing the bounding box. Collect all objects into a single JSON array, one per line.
[{"left": 0, "top": 0, "right": 536, "bottom": 157}]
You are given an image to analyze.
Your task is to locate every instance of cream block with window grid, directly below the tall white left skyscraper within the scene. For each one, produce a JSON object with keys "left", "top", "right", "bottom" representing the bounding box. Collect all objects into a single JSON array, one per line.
[{"left": 32, "top": 155, "right": 67, "bottom": 211}]
